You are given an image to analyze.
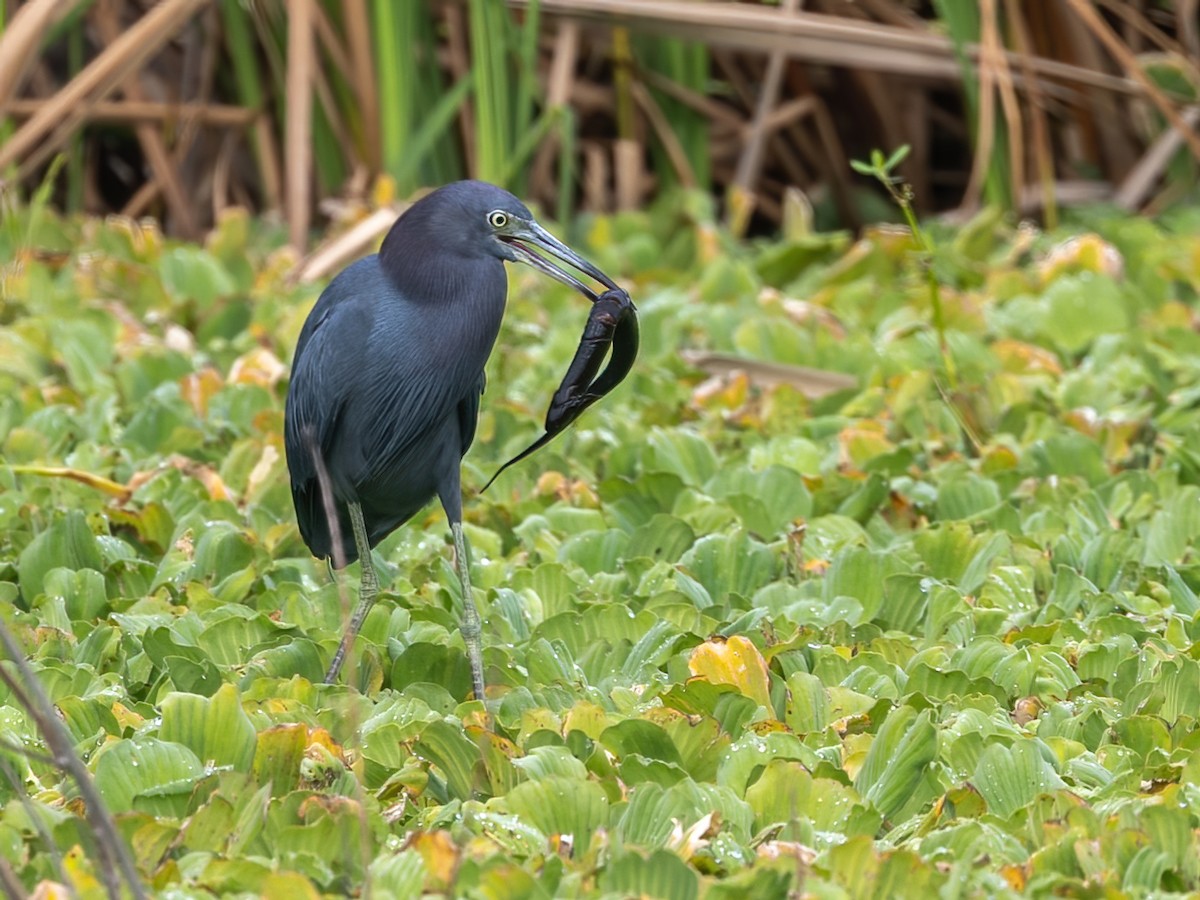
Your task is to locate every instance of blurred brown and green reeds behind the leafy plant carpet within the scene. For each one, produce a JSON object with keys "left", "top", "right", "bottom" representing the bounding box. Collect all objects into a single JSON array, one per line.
[{"left": 0, "top": 0, "right": 1200, "bottom": 250}]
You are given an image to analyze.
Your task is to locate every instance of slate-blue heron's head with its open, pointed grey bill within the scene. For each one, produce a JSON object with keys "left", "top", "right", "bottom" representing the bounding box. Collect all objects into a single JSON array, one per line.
[{"left": 380, "top": 181, "right": 617, "bottom": 300}]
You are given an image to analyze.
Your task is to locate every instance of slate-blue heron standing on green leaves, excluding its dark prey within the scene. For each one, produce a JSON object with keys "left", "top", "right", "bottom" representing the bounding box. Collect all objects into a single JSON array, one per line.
[{"left": 284, "top": 181, "right": 619, "bottom": 700}]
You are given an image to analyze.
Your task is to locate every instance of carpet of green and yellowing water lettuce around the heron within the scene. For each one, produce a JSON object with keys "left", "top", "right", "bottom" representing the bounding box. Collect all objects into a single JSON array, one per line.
[{"left": 0, "top": 198, "right": 1200, "bottom": 900}]
